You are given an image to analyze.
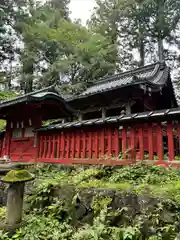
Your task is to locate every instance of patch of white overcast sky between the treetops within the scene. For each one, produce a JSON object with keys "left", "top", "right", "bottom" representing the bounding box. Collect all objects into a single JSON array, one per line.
[{"left": 69, "top": 0, "right": 95, "bottom": 24}]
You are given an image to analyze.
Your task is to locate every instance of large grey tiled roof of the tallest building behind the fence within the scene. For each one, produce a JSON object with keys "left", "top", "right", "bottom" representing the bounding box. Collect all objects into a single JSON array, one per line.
[{"left": 71, "top": 63, "right": 170, "bottom": 98}]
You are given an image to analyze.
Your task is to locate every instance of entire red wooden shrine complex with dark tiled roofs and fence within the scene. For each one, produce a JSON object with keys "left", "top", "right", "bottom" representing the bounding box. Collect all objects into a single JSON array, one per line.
[{"left": 0, "top": 63, "right": 180, "bottom": 165}]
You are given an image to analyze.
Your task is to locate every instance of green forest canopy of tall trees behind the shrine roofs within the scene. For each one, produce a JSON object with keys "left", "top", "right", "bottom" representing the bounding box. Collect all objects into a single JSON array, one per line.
[{"left": 0, "top": 0, "right": 180, "bottom": 93}]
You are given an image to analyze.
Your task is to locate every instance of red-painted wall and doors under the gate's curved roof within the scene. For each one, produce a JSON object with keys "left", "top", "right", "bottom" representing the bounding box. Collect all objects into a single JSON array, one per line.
[{"left": 1, "top": 107, "right": 42, "bottom": 162}]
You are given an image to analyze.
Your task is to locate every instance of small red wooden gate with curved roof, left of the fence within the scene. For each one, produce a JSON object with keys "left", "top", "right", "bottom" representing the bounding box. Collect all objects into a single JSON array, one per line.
[{"left": 0, "top": 86, "right": 73, "bottom": 161}]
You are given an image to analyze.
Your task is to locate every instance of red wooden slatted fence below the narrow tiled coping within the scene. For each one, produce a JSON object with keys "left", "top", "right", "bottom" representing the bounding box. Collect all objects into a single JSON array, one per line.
[{"left": 37, "top": 121, "right": 180, "bottom": 165}]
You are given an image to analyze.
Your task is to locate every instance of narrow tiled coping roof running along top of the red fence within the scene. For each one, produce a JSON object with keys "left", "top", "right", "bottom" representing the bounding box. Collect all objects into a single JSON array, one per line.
[{"left": 36, "top": 108, "right": 180, "bottom": 131}]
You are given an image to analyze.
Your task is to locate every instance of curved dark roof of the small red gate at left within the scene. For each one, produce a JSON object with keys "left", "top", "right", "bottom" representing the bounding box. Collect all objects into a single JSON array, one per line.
[{"left": 0, "top": 86, "right": 74, "bottom": 113}]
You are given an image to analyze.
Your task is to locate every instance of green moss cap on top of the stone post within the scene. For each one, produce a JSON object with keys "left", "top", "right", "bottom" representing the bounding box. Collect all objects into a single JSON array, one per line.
[{"left": 2, "top": 170, "right": 34, "bottom": 183}]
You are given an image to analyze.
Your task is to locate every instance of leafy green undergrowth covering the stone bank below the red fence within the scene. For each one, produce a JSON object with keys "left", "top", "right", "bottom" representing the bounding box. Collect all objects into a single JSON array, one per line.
[{"left": 0, "top": 164, "right": 180, "bottom": 240}]
